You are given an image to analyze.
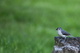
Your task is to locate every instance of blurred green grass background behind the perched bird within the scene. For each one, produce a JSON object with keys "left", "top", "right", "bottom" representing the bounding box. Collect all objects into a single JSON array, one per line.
[{"left": 0, "top": 0, "right": 80, "bottom": 53}]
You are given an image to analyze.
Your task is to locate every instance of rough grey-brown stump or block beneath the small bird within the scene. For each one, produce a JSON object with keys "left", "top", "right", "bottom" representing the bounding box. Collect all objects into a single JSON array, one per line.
[{"left": 52, "top": 37, "right": 80, "bottom": 53}]
